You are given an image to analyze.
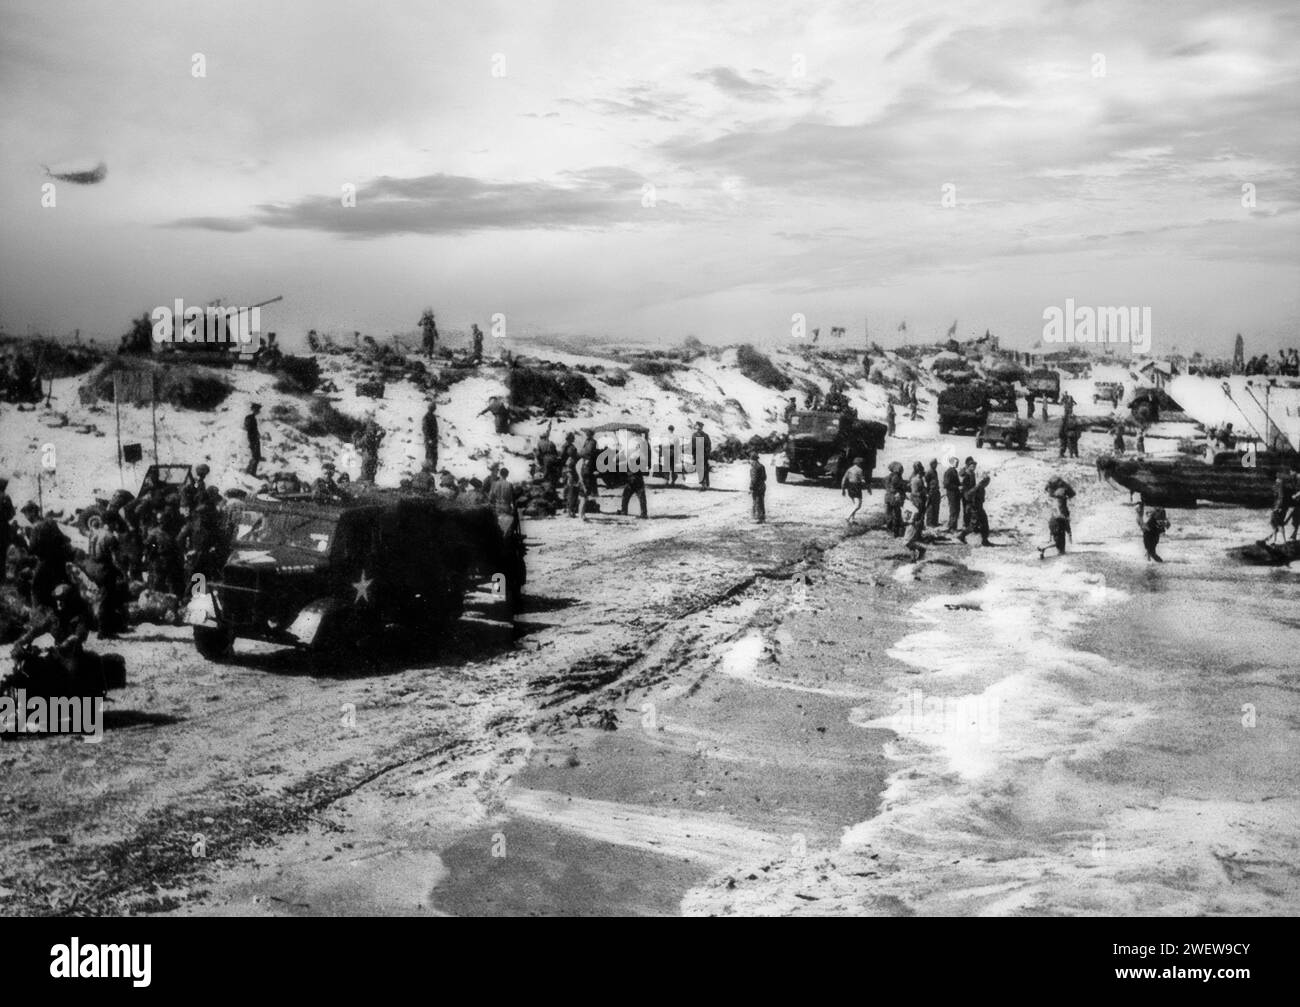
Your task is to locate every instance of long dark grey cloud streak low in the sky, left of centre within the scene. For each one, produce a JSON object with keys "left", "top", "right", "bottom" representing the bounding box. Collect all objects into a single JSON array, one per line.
[{"left": 168, "top": 166, "right": 671, "bottom": 238}]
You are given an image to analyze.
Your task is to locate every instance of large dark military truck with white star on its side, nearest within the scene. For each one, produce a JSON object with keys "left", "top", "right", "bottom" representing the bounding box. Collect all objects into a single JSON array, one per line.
[{"left": 186, "top": 491, "right": 527, "bottom": 660}]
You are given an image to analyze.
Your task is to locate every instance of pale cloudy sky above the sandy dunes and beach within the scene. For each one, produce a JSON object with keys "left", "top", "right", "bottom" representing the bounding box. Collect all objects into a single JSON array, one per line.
[{"left": 0, "top": 0, "right": 1300, "bottom": 352}]
